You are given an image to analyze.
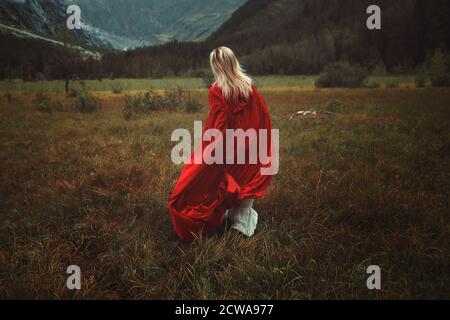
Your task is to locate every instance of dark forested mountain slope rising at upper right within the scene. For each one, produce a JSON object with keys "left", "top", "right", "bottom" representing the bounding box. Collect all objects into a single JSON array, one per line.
[{"left": 209, "top": 0, "right": 450, "bottom": 73}]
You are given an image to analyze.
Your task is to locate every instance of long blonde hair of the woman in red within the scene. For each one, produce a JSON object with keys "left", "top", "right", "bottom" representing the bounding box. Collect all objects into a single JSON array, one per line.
[{"left": 209, "top": 47, "right": 253, "bottom": 101}]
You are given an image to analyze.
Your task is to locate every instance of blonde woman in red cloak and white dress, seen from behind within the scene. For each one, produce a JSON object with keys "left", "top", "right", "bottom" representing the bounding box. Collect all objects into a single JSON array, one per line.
[{"left": 169, "top": 47, "right": 272, "bottom": 241}]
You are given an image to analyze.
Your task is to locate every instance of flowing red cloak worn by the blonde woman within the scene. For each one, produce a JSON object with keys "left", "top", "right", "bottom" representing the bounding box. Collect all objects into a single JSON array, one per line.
[{"left": 168, "top": 85, "right": 272, "bottom": 241}]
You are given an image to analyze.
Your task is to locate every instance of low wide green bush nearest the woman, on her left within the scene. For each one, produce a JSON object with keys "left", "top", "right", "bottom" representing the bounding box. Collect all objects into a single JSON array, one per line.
[{"left": 123, "top": 88, "right": 202, "bottom": 120}]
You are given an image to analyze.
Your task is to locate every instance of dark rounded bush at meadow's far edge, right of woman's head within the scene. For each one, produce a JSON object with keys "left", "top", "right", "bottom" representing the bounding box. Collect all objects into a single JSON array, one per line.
[{"left": 316, "top": 62, "right": 368, "bottom": 88}]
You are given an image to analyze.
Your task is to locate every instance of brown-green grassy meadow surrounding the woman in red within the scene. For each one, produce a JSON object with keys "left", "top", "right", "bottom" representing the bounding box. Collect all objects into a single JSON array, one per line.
[{"left": 0, "top": 77, "right": 450, "bottom": 299}]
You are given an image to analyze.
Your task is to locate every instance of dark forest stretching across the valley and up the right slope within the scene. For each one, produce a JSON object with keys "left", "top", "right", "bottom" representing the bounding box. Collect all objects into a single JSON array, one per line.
[{"left": 0, "top": 0, "right": 450, "bottom": 79}]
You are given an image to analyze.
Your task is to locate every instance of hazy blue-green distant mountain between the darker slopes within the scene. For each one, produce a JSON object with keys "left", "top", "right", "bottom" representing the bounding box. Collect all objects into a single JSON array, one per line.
[{"left": 71, "top": 0, "right": 246, "bottom": 43}]
